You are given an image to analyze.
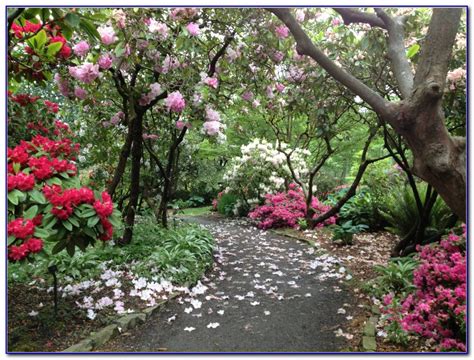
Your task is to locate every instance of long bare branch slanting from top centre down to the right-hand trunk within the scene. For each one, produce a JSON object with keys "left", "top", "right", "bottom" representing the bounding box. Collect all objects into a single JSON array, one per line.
[{"left": 267, "top": 8, "right": 392, "bottom": 117}]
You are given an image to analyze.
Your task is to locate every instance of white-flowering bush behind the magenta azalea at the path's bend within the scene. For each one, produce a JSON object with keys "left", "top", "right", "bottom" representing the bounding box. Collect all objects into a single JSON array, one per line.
[{"left": 223, "top": 139, "right": 311, "bottom": 199}]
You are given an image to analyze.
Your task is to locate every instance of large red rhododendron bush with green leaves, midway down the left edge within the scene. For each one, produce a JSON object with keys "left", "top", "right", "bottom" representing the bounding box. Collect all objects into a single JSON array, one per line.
[{"left": 7, "top": 93, "right": 119, "bottom": 261}]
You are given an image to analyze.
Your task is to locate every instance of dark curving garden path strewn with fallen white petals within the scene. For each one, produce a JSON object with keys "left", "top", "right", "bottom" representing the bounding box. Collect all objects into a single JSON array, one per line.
[{"left": 96, "top": 218, "right": 354, "bottom": 352}]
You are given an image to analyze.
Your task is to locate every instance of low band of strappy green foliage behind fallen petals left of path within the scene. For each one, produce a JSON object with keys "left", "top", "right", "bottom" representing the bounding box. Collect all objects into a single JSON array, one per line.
[{"left": 8, "top": 216, "right": 215, "bottom": 284}]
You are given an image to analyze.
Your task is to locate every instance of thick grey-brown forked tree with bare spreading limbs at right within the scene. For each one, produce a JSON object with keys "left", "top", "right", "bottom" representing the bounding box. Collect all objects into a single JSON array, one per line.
[{"left": 267, "top": 8, "right": 466, "bottom": 220}]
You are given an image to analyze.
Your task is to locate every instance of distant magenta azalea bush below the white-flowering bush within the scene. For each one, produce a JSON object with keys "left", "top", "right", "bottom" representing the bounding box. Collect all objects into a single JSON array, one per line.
[{"left": 249, "top": 184, "right": 336, "bottom": 229}]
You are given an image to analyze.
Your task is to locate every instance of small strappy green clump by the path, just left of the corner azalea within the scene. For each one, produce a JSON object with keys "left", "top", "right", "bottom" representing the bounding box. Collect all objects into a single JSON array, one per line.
[{"left": 366, "top": 256, "right": 419, "bottom": 298}]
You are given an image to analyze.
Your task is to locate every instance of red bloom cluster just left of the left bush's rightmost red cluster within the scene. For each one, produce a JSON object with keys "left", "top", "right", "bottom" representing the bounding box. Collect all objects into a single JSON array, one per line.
[{"left": 43, "top": 185, "right": 95, "bottom": 220}]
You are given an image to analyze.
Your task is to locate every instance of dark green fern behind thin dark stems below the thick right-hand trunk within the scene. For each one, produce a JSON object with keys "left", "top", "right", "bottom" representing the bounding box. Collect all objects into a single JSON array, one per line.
[{"left": 380, "top": 183, "right": 452, "bottom": 237}]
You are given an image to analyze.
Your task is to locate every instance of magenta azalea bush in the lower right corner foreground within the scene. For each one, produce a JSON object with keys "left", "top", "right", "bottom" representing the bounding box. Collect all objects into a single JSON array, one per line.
[{"left": 383, "top": 227, "right": 466, "bottom": 351}]
